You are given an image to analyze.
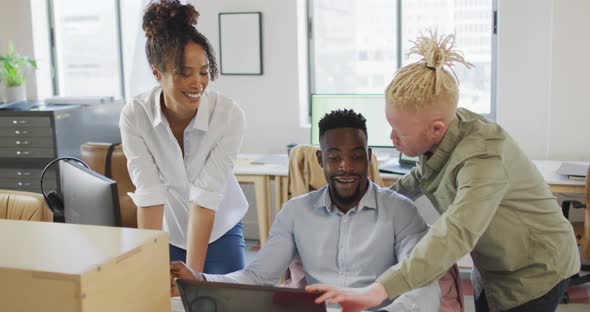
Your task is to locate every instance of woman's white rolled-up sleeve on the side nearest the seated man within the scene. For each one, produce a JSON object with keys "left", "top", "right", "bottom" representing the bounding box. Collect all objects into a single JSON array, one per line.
[{"left": 189, "top": 104, "right": 245, "bottom": 210}]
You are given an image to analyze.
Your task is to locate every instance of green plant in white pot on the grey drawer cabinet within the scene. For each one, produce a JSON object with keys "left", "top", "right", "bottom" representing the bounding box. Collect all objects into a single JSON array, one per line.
[{"left": 0, "top": 41, "right": 37, "bottom": 103}]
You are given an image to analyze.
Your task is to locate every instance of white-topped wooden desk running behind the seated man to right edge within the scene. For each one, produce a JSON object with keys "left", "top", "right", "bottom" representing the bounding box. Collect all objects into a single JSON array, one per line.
[{"left": 234, "top": 154, "right": 585, "bottom": 246}]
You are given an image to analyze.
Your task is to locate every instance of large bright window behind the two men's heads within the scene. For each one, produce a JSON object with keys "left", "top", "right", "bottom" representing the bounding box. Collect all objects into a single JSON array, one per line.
[{"left": 308, "top": 0, "right": 495, "bottom": 146}]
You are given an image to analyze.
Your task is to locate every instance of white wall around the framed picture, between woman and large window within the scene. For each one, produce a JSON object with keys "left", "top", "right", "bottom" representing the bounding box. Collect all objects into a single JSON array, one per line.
[{"left": 188, "top": 0, "right": 310, "bottom": 153}]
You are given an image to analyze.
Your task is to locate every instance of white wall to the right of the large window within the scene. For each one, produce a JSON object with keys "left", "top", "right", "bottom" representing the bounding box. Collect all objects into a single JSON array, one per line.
[{"left": 497, "top": 0, "right": 590, "bottom": 161}]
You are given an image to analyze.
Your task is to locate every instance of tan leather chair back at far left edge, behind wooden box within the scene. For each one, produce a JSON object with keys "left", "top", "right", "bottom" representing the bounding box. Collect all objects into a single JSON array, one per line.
[{"left": 0, "top": 190, "right": 53, "bottom": 222}]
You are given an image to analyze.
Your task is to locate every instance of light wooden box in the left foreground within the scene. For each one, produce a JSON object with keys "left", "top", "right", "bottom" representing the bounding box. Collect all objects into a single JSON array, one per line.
[{"left": 0, "top": 220, "right": 170, "bottom": 312}]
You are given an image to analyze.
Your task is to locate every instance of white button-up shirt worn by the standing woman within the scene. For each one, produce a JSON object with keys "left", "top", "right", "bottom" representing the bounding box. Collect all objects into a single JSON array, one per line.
[{"left": 119, "top": 87, "right": 248, "bottom": 249}]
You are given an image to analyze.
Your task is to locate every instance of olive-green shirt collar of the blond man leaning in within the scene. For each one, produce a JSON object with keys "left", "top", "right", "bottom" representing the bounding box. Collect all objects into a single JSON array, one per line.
[{"left": 420, "top": 108, "right": 463, "bottom": 172}]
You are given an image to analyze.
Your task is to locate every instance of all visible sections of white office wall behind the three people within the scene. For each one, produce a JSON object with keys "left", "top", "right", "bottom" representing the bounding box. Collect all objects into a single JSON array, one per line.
[{"left": 0, "top": 0, "right": 590, "bottom": 160}]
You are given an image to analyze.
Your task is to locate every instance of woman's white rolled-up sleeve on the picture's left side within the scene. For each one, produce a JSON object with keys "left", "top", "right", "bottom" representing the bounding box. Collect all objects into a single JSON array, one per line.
[{"left": 119, "top": 105, "right": 166, "bottom": 207}]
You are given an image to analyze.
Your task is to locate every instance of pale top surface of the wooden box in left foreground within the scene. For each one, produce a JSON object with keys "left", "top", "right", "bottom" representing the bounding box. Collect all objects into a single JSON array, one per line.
[{"left": 0, "top": 220, "right": 166, "bottom": 275}]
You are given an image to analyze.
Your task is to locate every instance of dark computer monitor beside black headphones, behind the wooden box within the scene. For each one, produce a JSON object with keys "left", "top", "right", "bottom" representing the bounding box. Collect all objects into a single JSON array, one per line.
[{"left": 60, "top": 161, "right": 121, "bottom": 226}]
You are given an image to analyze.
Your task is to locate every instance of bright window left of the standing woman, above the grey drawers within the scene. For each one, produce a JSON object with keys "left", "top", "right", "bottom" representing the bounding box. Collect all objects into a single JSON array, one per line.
[{"left": 49, "top": 0, "right": 124, "bottom": 97}]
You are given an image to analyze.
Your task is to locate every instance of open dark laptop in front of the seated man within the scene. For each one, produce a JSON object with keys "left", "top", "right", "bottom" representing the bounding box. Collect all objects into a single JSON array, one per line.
[{"left": 176, "top": 279, "right": 327, "bottom": 312}]
